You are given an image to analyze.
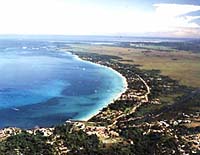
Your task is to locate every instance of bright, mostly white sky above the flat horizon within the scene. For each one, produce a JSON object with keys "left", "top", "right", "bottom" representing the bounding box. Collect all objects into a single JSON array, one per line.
[{"left": 0, "top": 0, "right": 200, "bottom": 38}]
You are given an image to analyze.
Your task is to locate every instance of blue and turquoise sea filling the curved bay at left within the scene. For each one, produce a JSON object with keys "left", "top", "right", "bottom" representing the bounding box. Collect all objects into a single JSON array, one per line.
[{"left": 0, "top": 39, "right": 125, "bottom": 128}]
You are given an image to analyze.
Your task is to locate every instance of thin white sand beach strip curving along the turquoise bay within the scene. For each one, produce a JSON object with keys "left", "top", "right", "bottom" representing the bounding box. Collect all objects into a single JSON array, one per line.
[{"left": 64, "top": 51, "right": 128, "bottom": 122}]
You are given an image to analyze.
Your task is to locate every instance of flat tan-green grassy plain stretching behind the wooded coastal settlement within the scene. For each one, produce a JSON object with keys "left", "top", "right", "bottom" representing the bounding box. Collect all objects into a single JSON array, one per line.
[{"left": 69, "top": 44, "right": 200, "bottom": 87}]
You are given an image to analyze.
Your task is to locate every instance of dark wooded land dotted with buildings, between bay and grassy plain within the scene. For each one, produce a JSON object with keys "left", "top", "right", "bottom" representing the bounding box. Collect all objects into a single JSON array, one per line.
[{"left": 0, "top": 43, "right": 200, "bottom": 155}]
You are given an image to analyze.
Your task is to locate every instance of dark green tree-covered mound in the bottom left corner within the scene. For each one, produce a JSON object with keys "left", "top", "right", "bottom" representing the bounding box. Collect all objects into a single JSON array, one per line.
[{"left": 0, "top": 132, "right": 54, "bottom": 155}]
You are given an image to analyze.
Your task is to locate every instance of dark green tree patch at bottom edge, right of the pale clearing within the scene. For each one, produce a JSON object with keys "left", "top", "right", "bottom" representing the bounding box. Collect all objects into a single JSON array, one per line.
[{"left": 121, "top": 128, "right": 180, "bottom": 155}]
